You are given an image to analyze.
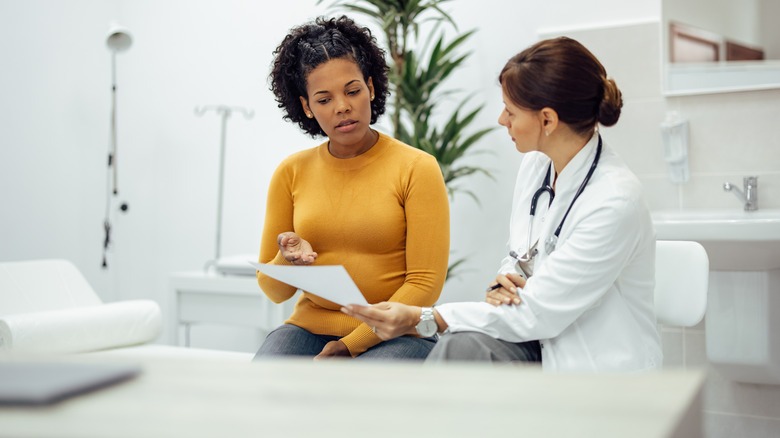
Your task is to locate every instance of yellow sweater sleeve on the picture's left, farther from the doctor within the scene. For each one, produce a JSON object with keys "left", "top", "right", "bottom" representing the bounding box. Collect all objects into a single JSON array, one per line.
[{"left": 257, "top": 162, "right": 297, "bottom": 303}]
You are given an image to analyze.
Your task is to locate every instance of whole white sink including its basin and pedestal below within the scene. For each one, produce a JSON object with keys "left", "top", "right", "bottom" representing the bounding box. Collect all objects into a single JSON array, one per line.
[{"left": 653, "top": 208, "right": 780, "bottom": 385}]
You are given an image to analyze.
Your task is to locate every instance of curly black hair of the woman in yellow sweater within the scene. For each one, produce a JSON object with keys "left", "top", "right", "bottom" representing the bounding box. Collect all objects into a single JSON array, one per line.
[{"left": 270, "top": 16, "right": 390, "bottom": 137}]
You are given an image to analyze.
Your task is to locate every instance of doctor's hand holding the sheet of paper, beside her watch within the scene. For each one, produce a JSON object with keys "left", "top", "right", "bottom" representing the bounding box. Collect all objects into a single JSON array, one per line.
[{"left": 341, "top": 302, "right": 422, "bottom": 341}]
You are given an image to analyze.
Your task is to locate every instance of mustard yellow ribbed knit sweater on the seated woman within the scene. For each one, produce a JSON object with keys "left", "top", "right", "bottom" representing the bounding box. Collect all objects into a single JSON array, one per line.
[{"left": 257, "top": 134, "right": 450, "bottom": 356}]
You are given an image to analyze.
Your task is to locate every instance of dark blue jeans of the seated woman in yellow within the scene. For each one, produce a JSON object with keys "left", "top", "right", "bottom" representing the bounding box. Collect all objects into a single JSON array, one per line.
[{"left": 253, "top": 324, "right": 436, "bottom": 360}]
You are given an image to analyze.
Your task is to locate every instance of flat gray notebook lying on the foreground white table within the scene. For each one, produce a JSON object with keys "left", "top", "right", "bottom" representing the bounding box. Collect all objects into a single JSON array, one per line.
[{"left": 0, "top": 362, "right": 141, "bottom": 406}]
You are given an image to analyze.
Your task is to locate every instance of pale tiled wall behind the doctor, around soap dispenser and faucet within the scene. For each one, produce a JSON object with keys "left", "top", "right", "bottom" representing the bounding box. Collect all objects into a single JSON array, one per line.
[{"left": 542, "top": 22, "right": 780, "bottom": 438}]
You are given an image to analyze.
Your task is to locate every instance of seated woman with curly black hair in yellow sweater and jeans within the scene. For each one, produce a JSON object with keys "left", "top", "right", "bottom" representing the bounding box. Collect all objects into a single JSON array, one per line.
[{"left": 255, "top": 17, "right": 449, "bottom": 359}]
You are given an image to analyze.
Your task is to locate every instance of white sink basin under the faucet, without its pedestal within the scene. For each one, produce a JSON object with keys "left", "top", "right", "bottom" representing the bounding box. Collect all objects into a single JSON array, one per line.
[{"left": 652, "top": 209, "right": 780, "bottom": 271}]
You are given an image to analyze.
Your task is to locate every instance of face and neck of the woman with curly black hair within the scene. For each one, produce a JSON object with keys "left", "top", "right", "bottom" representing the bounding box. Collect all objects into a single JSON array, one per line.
[{"left": 301, "top": 59, "right": 376, "bottom": 156}]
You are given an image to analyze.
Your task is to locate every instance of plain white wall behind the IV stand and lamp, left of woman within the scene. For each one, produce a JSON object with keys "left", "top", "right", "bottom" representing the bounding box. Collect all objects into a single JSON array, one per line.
[{"left": 0, "top": 0, "right": 325, "bottom": 336}]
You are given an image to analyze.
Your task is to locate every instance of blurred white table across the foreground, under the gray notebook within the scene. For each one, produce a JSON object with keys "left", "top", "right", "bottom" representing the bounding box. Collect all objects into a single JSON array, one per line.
[{"left": 0, "top": 356, "right": 704, "bottom": 438}]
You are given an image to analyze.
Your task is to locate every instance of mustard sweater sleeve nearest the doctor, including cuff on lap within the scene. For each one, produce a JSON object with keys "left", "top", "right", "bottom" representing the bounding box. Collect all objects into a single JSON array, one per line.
[{"left": 341, "top": 154, "right": 450, "bottom": 356}]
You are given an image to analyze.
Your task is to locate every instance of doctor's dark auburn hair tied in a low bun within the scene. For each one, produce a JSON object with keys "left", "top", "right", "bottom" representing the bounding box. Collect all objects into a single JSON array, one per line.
[{"left": 498, "top": 37, "right": 623, "bottom": 134}]
